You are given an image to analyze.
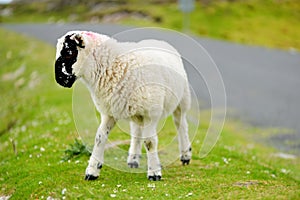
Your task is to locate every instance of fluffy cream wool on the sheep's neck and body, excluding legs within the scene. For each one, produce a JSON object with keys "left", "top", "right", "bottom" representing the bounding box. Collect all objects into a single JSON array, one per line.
[{"left": 57, "top": 31, "right": 188, "bottom": 120}]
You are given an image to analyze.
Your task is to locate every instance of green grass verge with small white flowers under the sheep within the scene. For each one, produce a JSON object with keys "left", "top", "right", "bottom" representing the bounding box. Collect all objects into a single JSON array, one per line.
[{"left": 0, "top": 29, "right": 300, "bottom": 199}]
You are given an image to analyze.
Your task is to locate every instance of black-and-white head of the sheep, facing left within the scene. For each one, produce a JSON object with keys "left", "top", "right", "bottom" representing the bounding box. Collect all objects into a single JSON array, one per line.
[{"left": 55, "top": 32, "right": 85, "bottom": 88}]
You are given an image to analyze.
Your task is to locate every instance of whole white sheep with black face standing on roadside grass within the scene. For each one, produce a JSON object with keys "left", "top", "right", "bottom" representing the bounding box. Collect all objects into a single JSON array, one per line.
[{"left": 55, "top": 31, "right": 192, "bottom": 181}]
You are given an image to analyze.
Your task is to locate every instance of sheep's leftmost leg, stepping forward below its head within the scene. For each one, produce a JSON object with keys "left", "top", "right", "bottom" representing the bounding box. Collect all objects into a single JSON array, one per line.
[{"left": 85, "top": 115, "right": 115, "bottom": 180}]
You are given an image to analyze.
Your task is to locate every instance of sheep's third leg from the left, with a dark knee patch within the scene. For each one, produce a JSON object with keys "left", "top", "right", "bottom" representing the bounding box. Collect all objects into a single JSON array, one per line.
[{"left": 143, "top": 124, "right": 162, "bottom": 181}]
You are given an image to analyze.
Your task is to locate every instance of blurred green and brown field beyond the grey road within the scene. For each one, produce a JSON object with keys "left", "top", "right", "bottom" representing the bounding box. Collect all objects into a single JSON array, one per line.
[{"left": 0, "top": 0, "right": 300, "bottom": 51}]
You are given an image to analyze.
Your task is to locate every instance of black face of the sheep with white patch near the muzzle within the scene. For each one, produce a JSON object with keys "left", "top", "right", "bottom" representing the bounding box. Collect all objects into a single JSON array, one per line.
[{"left": 55, "top": 35, "right": 84, "bottom": 88}]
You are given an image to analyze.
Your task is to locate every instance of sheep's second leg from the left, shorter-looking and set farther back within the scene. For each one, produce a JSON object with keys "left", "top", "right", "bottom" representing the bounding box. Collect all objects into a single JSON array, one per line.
[{"left": 127, "top": 122, "right": 142, "bottom": 168}]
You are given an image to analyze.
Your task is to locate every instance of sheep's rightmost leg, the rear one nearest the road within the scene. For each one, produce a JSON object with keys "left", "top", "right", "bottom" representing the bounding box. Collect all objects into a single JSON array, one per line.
[{"left": 173, "top": 106, "right": 192, "bottom": 165}]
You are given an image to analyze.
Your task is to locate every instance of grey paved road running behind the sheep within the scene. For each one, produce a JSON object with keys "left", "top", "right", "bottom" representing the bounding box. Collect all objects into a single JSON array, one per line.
[{"left": 2, "top": 24, "right": 300, "bottom": 152}]
